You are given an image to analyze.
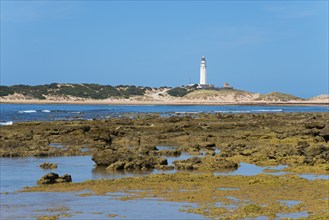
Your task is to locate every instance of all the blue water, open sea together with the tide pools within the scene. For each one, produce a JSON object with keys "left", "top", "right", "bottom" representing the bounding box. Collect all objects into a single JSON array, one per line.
[{"left": 0, "top": 104, "right": 329, "bottom": 219}]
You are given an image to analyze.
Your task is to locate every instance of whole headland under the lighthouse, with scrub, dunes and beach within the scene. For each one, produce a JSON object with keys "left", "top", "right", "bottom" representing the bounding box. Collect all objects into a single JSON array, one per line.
[{"left": 0, "top": 83, "right": 329, "bottom": 105}]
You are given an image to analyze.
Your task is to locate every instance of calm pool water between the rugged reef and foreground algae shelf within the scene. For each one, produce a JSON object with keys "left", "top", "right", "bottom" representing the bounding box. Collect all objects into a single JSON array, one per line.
[{"left": 5, "top": 153, "right": 328, "bottom": 192}]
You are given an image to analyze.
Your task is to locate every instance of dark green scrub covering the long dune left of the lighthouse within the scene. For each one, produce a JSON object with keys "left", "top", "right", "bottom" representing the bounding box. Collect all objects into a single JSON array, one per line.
[{"left": 0, "top": 83, "right": 151, "bottom": 99}]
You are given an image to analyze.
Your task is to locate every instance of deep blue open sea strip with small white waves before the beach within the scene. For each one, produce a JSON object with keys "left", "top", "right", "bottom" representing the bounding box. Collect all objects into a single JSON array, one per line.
[{"left": 0, "top": 104, "right": 329, "bottom": 125}]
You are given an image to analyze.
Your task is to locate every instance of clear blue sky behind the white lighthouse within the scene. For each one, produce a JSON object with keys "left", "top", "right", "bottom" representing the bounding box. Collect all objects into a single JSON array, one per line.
[{"left": 1, "top": 0, "right": 329, "bottom": 98}]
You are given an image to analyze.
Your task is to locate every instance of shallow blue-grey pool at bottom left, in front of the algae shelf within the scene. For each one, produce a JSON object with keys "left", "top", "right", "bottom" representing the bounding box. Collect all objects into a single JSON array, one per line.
[{"left": 1, "top": 192, "right": 205, "bottom": 219}]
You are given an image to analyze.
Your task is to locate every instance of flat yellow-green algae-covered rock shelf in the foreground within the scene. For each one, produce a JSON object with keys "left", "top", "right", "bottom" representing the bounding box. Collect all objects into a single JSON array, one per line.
[{"left": 23, "top": 172, "right": 329, "bottom": 219}]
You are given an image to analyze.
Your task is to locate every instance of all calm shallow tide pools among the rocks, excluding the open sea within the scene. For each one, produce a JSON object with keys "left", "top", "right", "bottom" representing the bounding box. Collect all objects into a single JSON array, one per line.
[{"left": 0, "top": 154, "right": 328, "bottom": 219}]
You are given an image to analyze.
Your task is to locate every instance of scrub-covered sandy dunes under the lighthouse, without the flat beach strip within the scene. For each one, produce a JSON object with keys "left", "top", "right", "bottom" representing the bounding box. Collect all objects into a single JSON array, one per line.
[{"left": 0, "top": 83, "right": 318, "bottom": 102}]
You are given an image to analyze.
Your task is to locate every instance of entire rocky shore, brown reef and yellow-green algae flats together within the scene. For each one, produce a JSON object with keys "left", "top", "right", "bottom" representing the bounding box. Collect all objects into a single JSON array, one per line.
[{"left": 4, "top": 113, "right": 329, "bottom": 219}]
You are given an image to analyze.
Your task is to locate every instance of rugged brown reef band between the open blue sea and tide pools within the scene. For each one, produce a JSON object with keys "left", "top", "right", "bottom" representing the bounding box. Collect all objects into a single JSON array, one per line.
[{"left": 0, "top": 113, "right": 329, "bottom": 173}]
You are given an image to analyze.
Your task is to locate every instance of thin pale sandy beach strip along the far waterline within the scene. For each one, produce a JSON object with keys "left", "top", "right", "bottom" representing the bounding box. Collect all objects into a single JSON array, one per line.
[{"left": 0, "top": 99, "right": 329, "bottom": 106}]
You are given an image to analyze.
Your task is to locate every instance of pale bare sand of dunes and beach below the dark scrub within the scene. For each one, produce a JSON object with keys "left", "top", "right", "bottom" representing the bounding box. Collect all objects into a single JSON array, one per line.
[{"left": 0, "top": 88, "right": 329, "bottom": 105}]
